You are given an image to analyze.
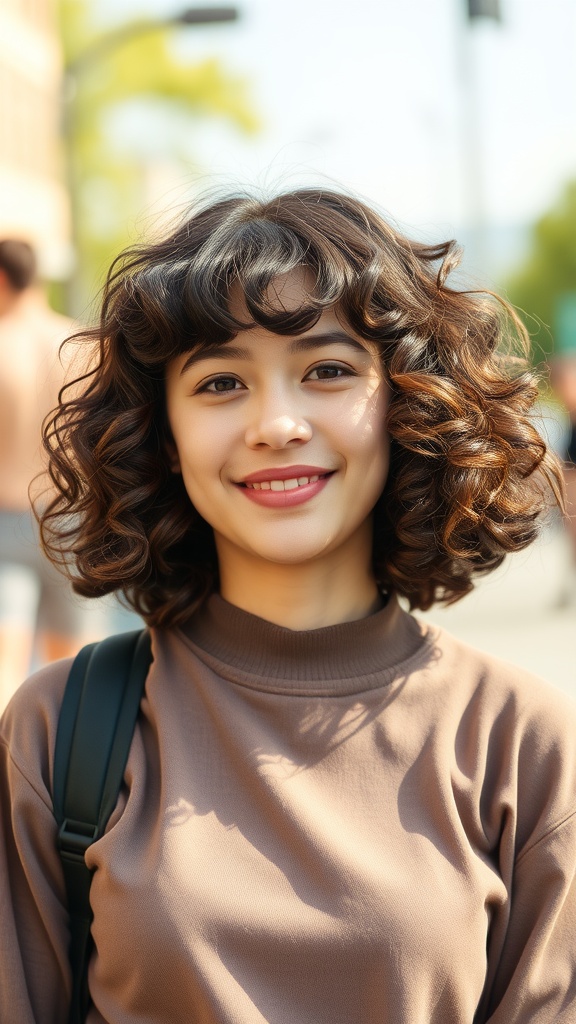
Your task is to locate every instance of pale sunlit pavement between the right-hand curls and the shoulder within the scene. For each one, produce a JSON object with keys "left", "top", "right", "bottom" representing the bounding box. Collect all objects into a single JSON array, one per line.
[{"left": 418, "top": 524, "right": 576, "bottom": 698}]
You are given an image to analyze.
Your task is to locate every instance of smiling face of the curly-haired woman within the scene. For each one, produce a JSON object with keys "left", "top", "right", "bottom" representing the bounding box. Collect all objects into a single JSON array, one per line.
[{"left": 166, "top": 272, "right": 388, "bottom": 577}]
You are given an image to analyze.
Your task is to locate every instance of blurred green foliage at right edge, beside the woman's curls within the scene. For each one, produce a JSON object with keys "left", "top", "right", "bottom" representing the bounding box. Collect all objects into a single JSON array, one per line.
[{"left": 507, "top": 181, "right": 576, "bottom": 362}]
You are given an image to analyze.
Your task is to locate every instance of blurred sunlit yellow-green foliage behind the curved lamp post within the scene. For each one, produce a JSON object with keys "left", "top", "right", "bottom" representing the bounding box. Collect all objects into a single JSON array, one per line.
[{"left": 59, "top": 0, "right": 257, "bottom": 314}]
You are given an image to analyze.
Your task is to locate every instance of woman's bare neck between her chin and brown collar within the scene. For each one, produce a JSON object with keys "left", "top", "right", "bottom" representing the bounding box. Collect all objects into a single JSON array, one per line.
[{"left": 215, "top": 554, "right": 382, "bottom": 630}]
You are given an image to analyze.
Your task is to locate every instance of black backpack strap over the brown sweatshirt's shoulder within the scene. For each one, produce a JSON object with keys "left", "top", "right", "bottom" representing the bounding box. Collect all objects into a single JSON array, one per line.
[{"left": 53, "top": 630, "right": 152, "bottom": 1024}]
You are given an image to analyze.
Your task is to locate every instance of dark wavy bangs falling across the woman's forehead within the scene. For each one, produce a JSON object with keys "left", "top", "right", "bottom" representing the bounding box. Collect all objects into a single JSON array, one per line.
[{"left": 125, "top": 192, "right": 391, "bottom": 359}]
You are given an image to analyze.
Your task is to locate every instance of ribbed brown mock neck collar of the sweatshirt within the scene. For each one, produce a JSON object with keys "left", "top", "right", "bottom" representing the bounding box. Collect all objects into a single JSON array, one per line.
[{"left": 180, "top": 594, "right": 430, "bottom": 694}]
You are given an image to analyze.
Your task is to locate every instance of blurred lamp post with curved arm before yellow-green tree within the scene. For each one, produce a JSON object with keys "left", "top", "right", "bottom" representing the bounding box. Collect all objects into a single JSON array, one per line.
[{"left": 63, "top": 6, "right": 239, "bottom": 315}]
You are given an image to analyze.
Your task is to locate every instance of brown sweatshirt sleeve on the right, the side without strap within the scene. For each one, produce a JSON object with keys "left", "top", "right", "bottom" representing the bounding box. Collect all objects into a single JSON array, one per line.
[{"left": 475, "top": 682, "right": 576, "bottom": 1024}]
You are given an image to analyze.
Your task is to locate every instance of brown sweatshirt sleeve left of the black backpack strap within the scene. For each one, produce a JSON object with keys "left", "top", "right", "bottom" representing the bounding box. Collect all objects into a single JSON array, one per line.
[{"left": 0, "top": 667, "right": 71, "bottom": 1024}]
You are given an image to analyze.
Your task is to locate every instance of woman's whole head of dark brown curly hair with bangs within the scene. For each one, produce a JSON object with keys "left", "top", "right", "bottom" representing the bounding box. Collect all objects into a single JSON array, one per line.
[{"left": 39, "top": 188, "right": 563, "bottom": 626}]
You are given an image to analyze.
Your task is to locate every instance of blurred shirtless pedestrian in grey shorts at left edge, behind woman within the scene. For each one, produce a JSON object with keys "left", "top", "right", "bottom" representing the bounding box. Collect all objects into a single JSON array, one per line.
[{"left": 0, "top": 239, "right": 94, "bottom": 707}]
